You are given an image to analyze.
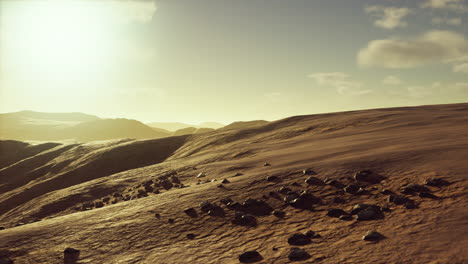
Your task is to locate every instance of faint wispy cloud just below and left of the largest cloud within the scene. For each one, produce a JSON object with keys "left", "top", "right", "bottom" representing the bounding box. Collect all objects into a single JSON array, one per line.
[{"left": 308, "top": 72, "right": 371, "bottom": 95}]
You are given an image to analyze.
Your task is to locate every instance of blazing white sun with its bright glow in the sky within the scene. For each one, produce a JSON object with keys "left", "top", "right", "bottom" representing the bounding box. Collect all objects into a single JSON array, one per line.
[{"left": 0, "top": 0, "right": 113, "bottom": 80}]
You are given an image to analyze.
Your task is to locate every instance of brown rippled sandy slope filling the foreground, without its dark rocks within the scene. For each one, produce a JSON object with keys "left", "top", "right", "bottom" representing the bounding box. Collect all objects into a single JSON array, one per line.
[{"left": 0, "top": 104, "right": 468, "bottom": 264}]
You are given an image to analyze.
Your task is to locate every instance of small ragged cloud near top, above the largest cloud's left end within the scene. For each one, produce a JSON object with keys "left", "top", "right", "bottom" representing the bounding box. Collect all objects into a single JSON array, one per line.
[{"left": 365, "top": 6, "right": 411, "bottom": 29}]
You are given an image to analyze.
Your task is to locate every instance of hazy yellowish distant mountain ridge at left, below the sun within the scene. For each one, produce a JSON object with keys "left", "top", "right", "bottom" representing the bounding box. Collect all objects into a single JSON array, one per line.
[{"left": 0, "top": 111, "right": 171, "bottom": 142}]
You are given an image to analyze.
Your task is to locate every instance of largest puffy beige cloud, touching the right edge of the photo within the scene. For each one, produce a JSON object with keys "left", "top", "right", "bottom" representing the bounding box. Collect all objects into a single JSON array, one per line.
[{"left": 357, "top": 30, "right": 468, "bottom": 69}]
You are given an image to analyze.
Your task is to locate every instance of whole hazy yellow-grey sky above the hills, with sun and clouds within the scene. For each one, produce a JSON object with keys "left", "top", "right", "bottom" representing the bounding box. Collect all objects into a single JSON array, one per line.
[{"left": 0, "top": 0, "right": 468, "bottom": 123}]
